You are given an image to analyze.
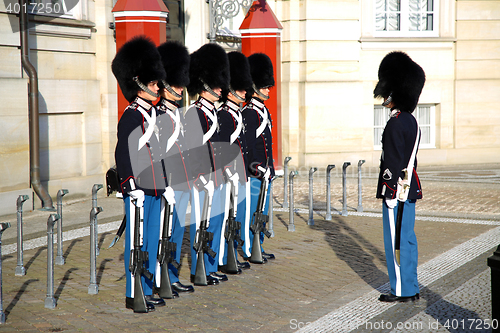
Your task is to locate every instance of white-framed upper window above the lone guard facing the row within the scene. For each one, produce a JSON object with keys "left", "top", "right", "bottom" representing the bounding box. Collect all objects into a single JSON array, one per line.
[{"left": 375, "top": 0, "right": 438, "bottom": 37}]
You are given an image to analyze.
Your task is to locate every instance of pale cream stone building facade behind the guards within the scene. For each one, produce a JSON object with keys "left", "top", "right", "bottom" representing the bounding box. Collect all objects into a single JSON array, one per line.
[{"left": 0, "top": 0, "right": 500, "bottom": 213}]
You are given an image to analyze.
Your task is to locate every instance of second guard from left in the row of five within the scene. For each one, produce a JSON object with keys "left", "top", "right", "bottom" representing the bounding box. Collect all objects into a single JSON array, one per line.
[{"left": 156, "top": 41, "right": 194, "bottom": 297}]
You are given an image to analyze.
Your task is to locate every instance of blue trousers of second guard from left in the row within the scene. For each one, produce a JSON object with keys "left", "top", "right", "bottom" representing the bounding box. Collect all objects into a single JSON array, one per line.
[{"left": 168, "top": 191, "right": 193, "bottom": 283}]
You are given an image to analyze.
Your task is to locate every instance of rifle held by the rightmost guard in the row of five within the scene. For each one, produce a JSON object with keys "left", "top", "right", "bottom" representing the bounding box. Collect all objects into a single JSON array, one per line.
[{"left": 249, "top": 166, "right": 271, "bottom": 264}]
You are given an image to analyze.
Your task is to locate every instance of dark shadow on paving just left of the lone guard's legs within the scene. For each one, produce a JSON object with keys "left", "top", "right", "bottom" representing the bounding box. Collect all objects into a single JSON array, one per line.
[{"left": 308, "top": 215, "right": 389, "bottom": 289}]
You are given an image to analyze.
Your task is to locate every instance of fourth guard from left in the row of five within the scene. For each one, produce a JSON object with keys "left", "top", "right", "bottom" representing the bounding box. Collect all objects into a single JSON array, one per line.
[{"left": 217, "top": 51, "right": 252, "bottom": 274}]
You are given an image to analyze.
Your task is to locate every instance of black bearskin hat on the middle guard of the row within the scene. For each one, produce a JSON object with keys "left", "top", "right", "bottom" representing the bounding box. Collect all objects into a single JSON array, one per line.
[{"left": 187, "top": 43, "right": 229, "bottom": 96}]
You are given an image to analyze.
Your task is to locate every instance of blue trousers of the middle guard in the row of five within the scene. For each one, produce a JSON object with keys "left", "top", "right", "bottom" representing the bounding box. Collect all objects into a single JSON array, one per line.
[{"left": 189, "top": 185, "right": 224, "bottom": 275}]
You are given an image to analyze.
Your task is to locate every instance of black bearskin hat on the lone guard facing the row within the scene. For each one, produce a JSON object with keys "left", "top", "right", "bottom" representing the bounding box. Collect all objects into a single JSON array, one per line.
[{"left": 373, "top": 51, "right": 425, "bottom": 113}]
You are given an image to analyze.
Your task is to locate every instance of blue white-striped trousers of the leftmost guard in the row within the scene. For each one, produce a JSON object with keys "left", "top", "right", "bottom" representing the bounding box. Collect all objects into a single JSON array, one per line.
[{"left": 123, "top": 195, "right": 162, "bottom": 297}]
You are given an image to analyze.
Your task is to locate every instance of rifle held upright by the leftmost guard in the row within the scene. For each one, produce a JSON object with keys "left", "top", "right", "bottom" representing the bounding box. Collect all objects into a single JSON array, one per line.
[{"left": 129, "top": 200, "right": 153, "bottom": 313}]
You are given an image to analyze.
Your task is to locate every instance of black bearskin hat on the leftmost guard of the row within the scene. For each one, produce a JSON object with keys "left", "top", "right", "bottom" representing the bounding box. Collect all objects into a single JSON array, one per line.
[{"left": 111, "top": 36, "right": 165, "bottom": 102}]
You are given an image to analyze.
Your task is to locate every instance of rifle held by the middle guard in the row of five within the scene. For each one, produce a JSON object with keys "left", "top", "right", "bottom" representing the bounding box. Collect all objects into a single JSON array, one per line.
[{"left": 193, "top": 176, "right": 217, "bottom": 286}]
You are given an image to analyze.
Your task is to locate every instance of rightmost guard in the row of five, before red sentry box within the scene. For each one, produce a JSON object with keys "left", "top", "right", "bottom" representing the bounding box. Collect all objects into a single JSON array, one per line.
[{"left": 242, "top": 53, "right": 275, "bottom": 263}]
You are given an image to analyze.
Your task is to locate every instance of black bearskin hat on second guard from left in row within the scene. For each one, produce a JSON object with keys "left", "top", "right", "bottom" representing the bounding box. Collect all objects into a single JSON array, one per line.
[{"left": 158, "top": 41, "right": 189, "bottom": 87}]
